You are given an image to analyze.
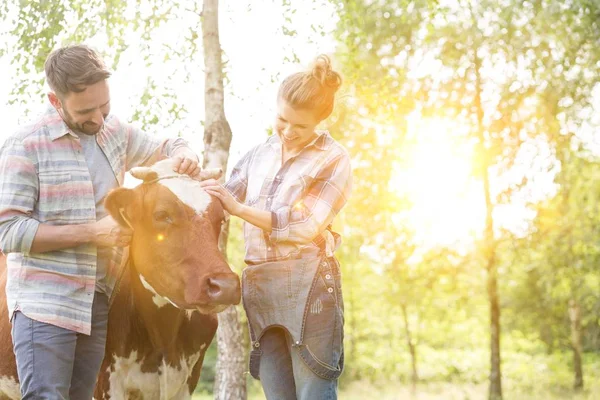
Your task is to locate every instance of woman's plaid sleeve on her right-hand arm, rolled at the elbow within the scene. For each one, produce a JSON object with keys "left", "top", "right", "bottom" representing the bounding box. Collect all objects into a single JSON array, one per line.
[{"left": 270, "top": 153, "right": 352, "bottom": 244}]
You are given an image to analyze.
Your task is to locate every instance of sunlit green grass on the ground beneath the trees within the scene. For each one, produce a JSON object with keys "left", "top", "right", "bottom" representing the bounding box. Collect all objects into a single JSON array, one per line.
[{"left": 193, "top": 350, "right": 600, "bottom": 400}]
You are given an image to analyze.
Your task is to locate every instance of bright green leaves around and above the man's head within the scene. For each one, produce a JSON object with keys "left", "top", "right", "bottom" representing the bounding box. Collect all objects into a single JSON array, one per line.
[{"left": 0, "top": 0, "right": 201, "bottom": 131}]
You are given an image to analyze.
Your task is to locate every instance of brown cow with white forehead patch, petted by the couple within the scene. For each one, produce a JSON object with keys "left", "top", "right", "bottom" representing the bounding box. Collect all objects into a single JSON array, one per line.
[{"left": 0, "top": 159, "right": 241, "bottom": 400}]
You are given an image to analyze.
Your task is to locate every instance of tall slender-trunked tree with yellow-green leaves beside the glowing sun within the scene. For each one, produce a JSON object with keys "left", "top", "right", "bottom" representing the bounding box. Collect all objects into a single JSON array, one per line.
[{"left": 330, "top": 0, "right": 599, "bottom": 399}]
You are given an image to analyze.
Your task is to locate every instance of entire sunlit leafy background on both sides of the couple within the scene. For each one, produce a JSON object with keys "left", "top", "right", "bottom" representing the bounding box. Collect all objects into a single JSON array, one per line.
[{"left": 0, "top": 0, "right": 600, "bottom": 399}]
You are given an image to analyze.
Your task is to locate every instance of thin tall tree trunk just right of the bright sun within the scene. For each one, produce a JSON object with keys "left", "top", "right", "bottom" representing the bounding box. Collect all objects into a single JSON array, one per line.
[{"left": 473, "top": 52, "right": 502, "bottom": 400}]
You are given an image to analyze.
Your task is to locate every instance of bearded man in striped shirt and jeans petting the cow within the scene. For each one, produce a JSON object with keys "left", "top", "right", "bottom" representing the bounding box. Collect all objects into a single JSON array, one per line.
[{"left": 0, "top": 45, "right": 200, "bottom": 400}]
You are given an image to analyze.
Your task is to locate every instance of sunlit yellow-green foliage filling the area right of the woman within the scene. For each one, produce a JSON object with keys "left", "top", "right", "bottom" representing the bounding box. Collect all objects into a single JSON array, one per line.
[{"left": 335, "top": 0, "right": 600, "bottom": 385}]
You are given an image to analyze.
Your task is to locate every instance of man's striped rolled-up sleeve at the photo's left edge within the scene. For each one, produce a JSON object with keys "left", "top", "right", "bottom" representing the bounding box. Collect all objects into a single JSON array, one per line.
[{"left": 0, "top": 138, "right": 40, "bottom": 253}]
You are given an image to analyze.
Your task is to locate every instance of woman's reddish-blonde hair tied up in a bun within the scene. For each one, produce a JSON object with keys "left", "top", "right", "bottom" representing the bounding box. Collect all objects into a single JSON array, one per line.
[{"left": 277, "top": 54, "right": 342, "bottom": 121}]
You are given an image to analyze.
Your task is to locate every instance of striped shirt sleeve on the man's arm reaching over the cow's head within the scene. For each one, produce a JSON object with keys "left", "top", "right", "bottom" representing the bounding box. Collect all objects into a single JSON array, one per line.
[{"left": 123, "top": 124, "right": 191, "bottom": 170}]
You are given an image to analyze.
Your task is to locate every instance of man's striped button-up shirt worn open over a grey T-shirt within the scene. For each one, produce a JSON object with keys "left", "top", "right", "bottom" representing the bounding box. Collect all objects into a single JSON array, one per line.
[{"left": 0, "top": 107, "right": 191, "bottom": 334}]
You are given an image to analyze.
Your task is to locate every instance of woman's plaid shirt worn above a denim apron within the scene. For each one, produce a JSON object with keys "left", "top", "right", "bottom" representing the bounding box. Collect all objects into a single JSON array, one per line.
[{"left": 225, "top": 132, "right": 352, "bottom": 264}]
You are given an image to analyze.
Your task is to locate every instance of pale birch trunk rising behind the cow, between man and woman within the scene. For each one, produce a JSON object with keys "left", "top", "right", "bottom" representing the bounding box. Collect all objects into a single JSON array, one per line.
[{"left": 202, "top": 0, "right": 246, "bottom": 400}]
